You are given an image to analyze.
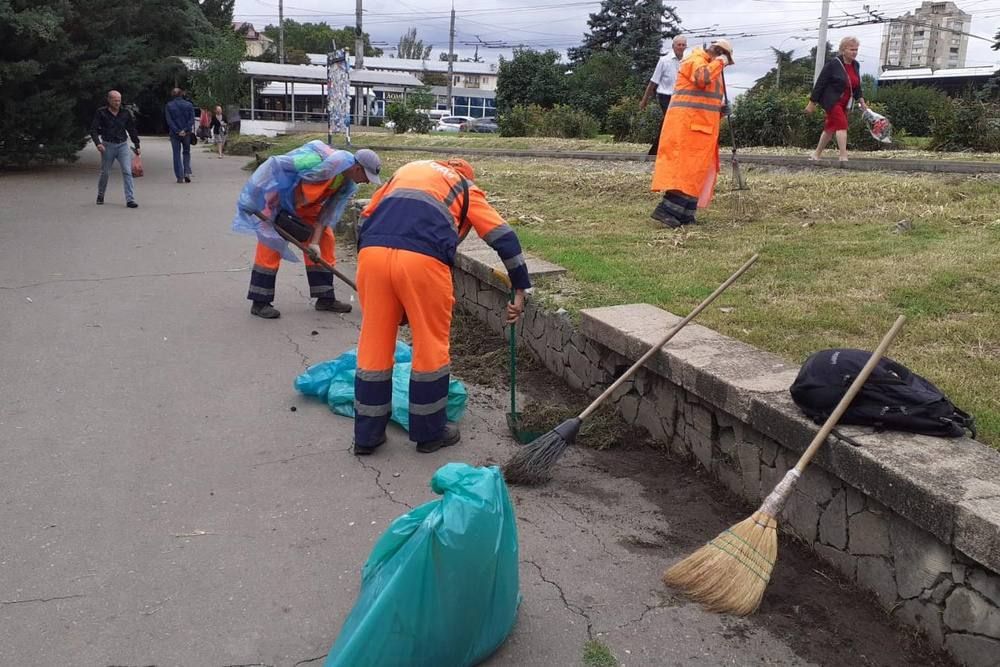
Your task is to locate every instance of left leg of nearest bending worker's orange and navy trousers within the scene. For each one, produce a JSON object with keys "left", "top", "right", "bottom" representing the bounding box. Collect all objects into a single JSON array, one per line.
[{"left": 354, "top": 247, "right": 403, "bottom": 447}]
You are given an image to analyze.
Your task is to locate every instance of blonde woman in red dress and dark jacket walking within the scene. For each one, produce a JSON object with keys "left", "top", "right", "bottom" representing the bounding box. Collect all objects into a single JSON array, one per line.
[{"left": 806, "top": 37, "right": 867, "bottom": 163}]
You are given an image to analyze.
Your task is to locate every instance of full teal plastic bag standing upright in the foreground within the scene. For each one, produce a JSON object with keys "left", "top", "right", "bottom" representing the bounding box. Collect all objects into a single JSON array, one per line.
[{"left": 325, "top": 463, "right": 521, "bottom": 667}]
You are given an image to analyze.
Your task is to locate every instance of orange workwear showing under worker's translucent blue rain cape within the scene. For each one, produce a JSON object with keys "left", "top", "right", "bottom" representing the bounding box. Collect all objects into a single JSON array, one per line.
[{"left": 247, "top": 174, "right": 344, "bottom": 303}]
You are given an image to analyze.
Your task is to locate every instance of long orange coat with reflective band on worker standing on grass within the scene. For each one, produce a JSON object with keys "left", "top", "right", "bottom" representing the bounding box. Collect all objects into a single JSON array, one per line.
[{"left": 652, "top": 49, "right": 724, "bottom": 201}]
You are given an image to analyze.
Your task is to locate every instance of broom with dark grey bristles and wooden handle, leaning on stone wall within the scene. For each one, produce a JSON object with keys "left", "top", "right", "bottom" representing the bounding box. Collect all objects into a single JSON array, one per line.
[{"left": 503, "top": 255, "right": 759, "bottom": 485}]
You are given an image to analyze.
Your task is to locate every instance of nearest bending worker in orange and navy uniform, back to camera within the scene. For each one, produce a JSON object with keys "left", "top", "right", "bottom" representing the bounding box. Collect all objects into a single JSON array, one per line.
[{"left": 354, "top": 158, "right": 531, "bottom": 455}]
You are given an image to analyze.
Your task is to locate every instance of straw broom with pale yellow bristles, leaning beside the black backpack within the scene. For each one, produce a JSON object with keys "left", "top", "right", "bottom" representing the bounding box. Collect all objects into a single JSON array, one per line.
[{"left": 663, "top": 315, "right": 906, "bottom": 616}]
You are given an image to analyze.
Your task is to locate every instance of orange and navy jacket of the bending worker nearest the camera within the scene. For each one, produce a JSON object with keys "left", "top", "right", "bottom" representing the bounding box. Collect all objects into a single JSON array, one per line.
[{"left": 358, "top": 160, "right": 531, "bottom": 289}]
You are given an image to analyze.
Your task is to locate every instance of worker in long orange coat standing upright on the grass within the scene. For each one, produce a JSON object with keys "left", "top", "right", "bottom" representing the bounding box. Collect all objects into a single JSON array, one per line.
[{"left": 652, "top": 39, "right": 734, "bottom": 228}]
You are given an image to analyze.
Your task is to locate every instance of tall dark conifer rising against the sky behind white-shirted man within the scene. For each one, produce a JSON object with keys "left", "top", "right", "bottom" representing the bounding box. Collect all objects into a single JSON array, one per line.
[{"left": 569, "top": 0, "right": 681, "bottom": 76}]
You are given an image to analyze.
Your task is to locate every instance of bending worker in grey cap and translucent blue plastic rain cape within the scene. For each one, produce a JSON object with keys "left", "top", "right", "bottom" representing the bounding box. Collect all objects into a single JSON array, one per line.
[{"left": 241, "top": 141, "right": 381, "bottom": 320}]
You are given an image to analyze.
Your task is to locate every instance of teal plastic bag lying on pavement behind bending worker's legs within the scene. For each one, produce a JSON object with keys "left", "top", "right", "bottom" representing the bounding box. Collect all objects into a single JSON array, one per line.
[{"left": 295, "top": 341, "right": 468, "bottom": 431}]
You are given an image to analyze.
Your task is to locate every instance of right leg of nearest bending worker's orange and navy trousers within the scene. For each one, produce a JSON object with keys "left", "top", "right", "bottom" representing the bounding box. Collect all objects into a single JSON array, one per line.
[{"left": 392, "top": 250, "right": 455, "bottom": 442}]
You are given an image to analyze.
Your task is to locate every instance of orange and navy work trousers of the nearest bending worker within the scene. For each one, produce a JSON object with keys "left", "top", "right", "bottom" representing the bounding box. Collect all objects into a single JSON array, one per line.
[{"left": 354, "top": 246, "right": 455, "bottom": 447}]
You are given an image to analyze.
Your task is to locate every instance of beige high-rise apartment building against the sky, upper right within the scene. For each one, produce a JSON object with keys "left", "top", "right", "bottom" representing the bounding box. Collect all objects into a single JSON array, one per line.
[{"left": 880, "top": 2, "right": 972, "bottom": 70}]
